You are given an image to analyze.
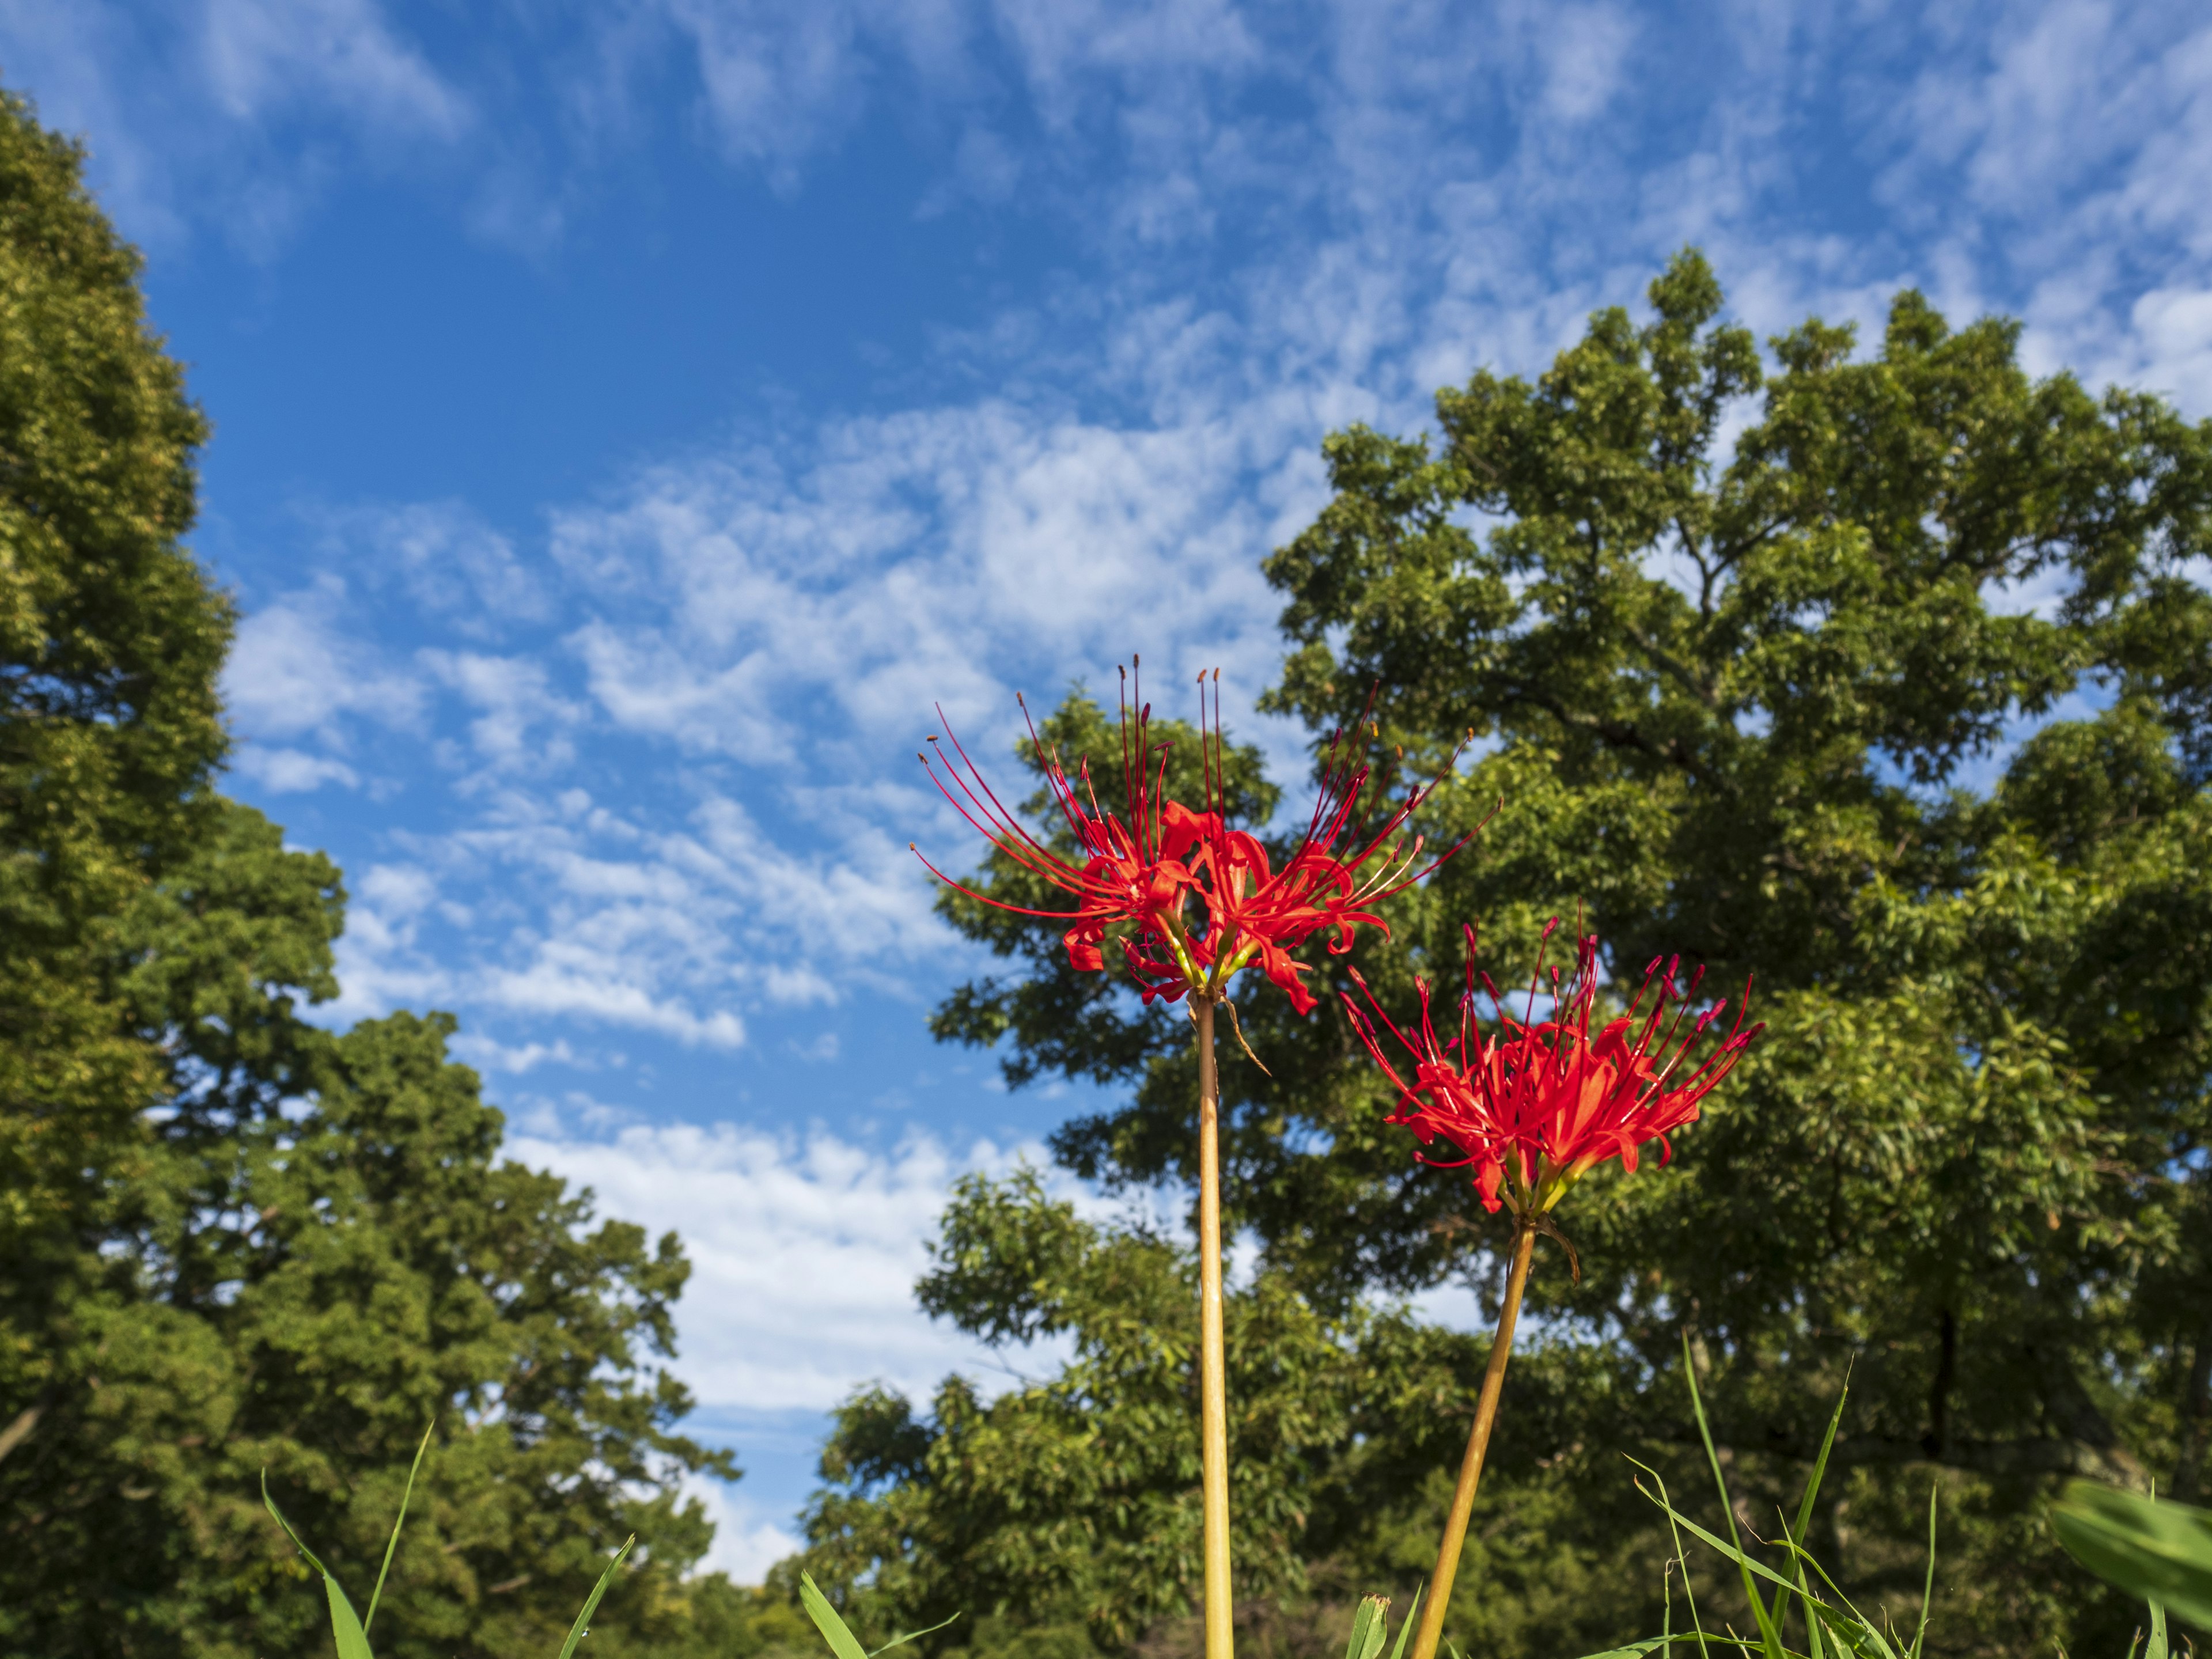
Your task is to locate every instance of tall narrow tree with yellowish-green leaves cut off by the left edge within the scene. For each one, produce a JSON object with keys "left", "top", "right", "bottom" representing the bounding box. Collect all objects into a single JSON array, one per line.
[{"left": 0, "top": 93, "right": 230, "bottom": 1440}]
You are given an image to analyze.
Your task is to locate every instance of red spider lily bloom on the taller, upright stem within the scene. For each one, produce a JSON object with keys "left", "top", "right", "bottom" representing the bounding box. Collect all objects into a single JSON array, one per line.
[{"left": 922, "top": 671, "right": 1473, "bottom": 1013}]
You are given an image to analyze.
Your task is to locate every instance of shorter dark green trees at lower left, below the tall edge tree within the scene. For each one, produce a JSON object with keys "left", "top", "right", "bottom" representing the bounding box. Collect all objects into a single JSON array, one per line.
[{"left": 0, "top": 787, "right": 745, "bottom": 1654}]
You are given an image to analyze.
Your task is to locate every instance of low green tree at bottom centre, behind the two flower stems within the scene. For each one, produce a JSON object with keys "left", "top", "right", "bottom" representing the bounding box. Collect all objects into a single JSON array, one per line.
[{"left": 796, "top": 1172, "right": 1661, "bottom": 1659}]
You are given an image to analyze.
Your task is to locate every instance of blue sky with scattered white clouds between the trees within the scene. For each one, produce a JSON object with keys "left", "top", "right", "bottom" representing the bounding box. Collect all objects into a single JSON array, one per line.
[{"left": 0, "top": 0, "right": 2212, "bottom": 1575}]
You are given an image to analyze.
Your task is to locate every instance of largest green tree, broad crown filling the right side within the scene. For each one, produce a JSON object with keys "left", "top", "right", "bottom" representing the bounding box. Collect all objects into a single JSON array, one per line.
[{"left": 902, "top": 252, "right": 2212, "bottom": 1652}]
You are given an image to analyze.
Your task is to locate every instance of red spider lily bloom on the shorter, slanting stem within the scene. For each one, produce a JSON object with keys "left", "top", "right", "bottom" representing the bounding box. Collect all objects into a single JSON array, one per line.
[{"left": 1345, "top": 918, "right": 1765, "bottom": 1217}]
